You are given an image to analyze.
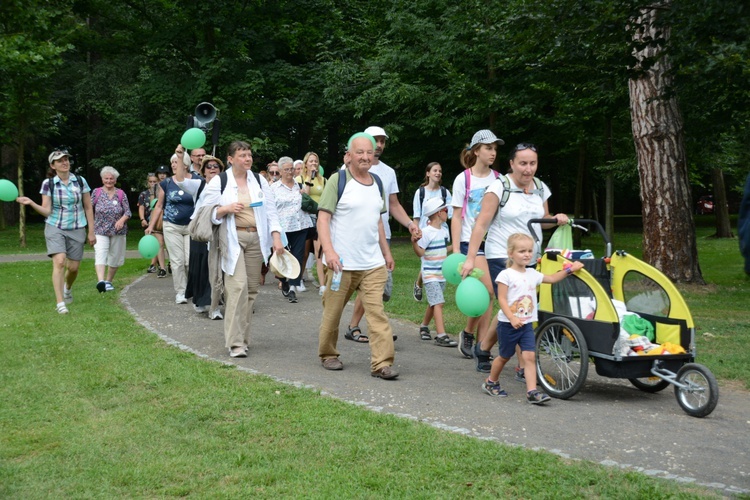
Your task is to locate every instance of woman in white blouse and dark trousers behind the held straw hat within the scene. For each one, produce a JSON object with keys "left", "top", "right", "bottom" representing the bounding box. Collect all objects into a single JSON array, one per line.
[{"left": 271, "top": 156, "right": 312, "bottom": 304}]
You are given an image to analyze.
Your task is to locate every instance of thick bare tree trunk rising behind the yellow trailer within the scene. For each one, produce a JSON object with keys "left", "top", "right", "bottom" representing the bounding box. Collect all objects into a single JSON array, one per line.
[{"left": 629, "top": 0, "right": 705, "bottom": 284}]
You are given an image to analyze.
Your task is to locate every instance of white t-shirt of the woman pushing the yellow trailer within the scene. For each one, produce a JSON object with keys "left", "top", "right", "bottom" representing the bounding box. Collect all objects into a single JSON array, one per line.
[{"left": 484, "top": 176, "right": 552, "bottom": 259}]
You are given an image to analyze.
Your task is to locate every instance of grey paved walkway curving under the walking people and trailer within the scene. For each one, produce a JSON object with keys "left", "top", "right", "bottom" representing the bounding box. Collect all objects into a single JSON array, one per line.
[{"left": 0, "top": 256, "right": 750, "bottom": 495}]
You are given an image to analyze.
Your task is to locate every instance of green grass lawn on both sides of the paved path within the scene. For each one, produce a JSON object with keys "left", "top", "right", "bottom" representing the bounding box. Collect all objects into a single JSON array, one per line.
[{"left": 0, "top": 219, "right": 750, "bottom": 498}]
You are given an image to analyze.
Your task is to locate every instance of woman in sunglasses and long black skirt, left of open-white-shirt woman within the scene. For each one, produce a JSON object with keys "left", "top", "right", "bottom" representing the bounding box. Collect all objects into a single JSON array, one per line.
[{"left": 174, "top": 145, "right": 224, "bottom": 319}]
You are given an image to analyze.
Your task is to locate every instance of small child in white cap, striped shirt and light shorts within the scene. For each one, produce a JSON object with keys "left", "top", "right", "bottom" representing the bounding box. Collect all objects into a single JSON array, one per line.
[{"left": 411, "top": 197, "right": 458, "bottom": 347}]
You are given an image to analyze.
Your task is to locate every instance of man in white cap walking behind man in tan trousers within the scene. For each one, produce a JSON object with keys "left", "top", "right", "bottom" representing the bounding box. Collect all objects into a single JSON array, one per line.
[{"left": 345, "top": 125, "right": 421, "bottom": 342}]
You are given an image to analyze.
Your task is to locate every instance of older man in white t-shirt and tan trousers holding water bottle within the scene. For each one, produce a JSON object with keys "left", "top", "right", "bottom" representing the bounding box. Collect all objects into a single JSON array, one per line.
[{"left": 318, "top": 133, "right": 398, "bottom": 380}]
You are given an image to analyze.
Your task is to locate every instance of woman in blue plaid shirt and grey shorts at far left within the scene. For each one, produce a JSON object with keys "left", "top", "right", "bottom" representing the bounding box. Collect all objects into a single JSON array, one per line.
[{"left": 16, "top": 149, "right": 96, "bottom": 314}]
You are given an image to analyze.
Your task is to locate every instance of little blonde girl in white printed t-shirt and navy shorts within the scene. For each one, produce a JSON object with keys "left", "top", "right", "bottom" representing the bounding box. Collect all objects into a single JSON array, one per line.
[{"left": 482, "top": 233, "right": 583, "bottom": 404}]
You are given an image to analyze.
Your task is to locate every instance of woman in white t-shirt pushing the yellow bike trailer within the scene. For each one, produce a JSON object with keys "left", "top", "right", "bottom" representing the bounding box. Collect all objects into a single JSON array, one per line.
[{"left": 461, "top": 143, "right": 568, "bottom": 376}]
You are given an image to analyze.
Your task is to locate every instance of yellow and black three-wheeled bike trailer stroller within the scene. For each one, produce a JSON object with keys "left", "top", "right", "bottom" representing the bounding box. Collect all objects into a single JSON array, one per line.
[{"left": 528, "top": 219, "right": 719, "bottom": 417}]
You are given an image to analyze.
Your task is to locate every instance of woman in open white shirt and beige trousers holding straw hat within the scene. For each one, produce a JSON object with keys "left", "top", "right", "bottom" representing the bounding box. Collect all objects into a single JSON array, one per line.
[{"left": 203, "top": 141, "right": 284, "bottom": 358}]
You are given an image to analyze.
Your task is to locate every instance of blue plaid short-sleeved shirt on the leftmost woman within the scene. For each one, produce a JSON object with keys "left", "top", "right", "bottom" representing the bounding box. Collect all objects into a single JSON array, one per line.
[{"left": 39, "top": 173, "right": 91, "bottom": 229}]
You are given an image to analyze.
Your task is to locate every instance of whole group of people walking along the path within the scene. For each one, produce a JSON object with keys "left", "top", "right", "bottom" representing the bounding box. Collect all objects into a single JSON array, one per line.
[{"left": 18, "top": 126, "right": 577, "bottom": 403}]
